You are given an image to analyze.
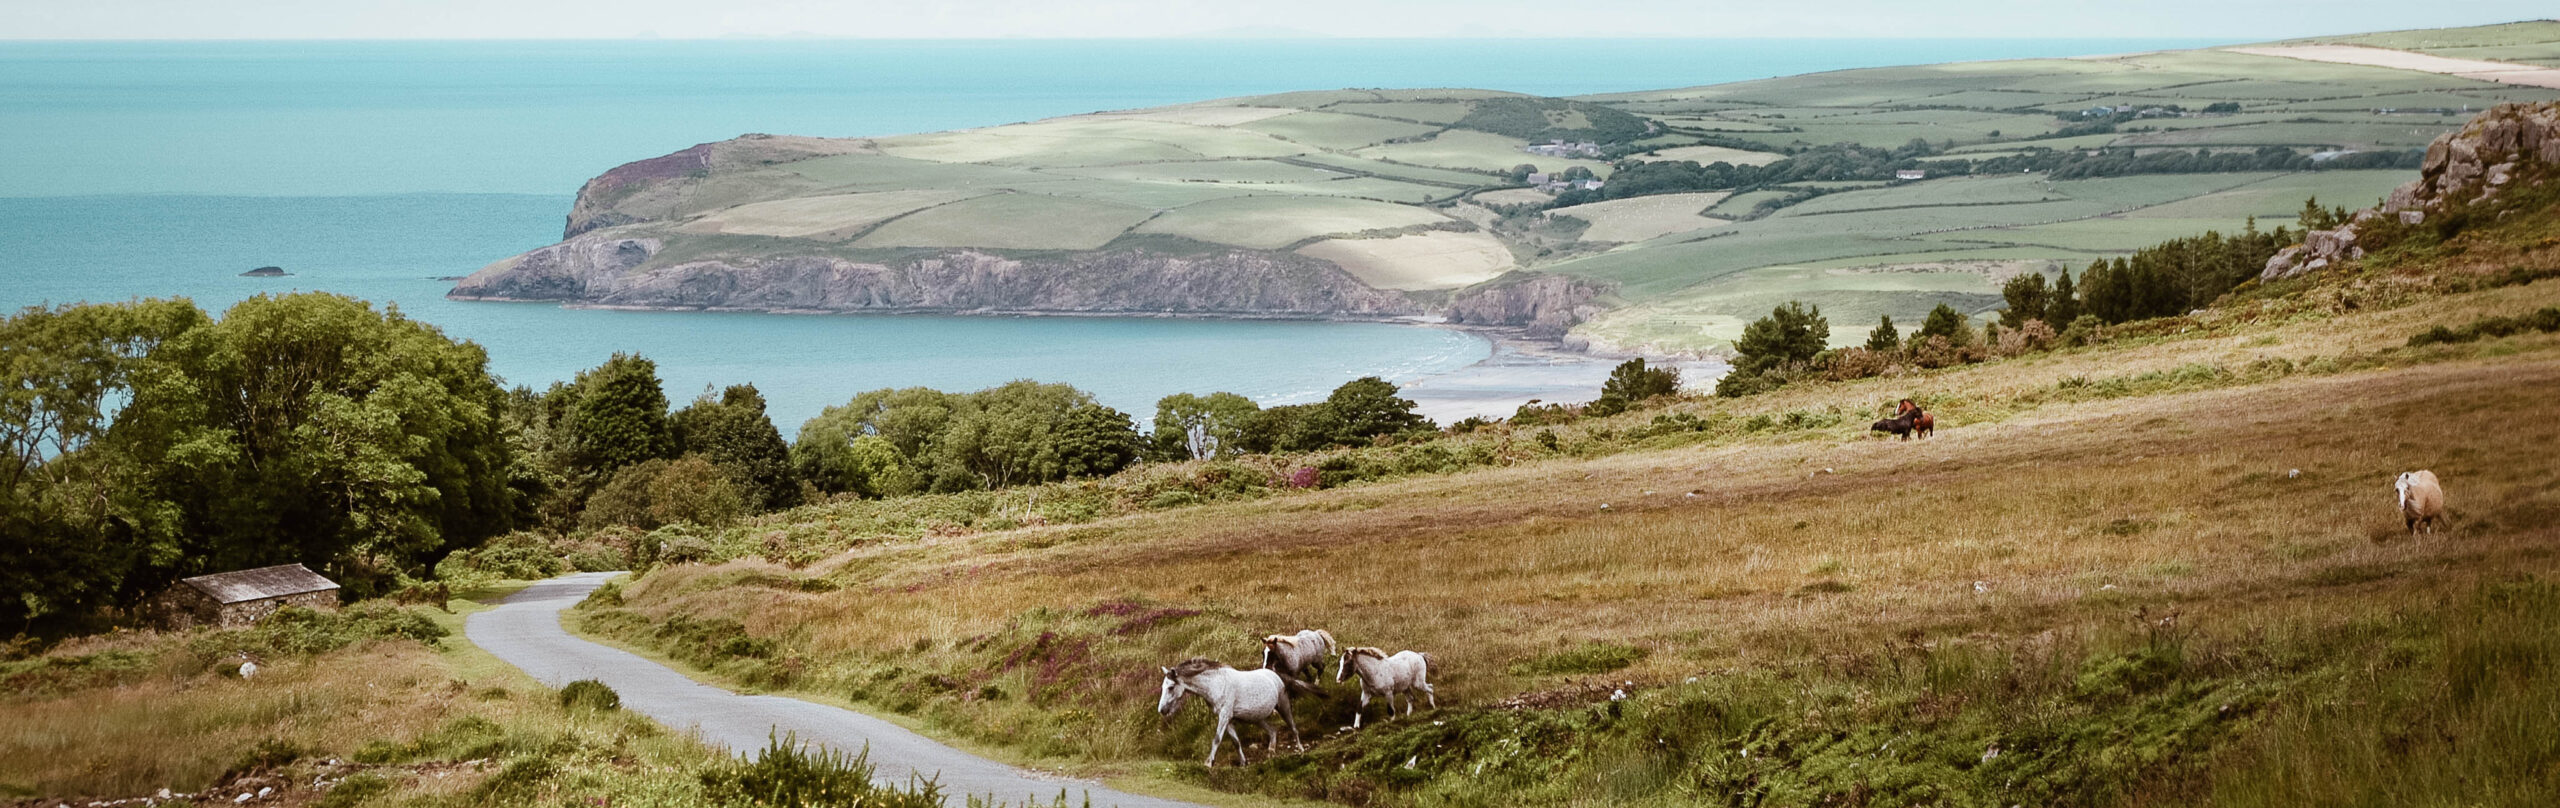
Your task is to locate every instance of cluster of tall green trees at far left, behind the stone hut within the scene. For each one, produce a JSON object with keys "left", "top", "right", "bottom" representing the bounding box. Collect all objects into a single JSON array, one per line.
[{"left": 0, "top": 294, "right": 520, "bottom": 621}]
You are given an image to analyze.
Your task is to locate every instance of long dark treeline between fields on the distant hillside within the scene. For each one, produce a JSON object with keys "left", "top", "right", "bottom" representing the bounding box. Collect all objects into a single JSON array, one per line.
[{"left": 1549, "top": 141, "right": 2424, "bottom": 207}]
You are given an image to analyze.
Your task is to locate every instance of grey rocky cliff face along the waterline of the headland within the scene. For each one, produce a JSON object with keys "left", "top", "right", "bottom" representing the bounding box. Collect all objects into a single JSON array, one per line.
[{"left": 445, "top": 230, "right": 1421, "bottom": 317}]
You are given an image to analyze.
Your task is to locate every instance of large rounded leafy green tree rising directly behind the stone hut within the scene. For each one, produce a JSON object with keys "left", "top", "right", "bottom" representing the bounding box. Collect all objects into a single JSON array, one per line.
[{"left": 113, "top": 294, "right": 512, "bottom": 586}]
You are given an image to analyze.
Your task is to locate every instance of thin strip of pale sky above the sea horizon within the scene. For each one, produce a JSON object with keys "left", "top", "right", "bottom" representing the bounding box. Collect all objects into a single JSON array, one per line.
[{"left": 0, "top": 0, "right": 2555, "bottom": 41}]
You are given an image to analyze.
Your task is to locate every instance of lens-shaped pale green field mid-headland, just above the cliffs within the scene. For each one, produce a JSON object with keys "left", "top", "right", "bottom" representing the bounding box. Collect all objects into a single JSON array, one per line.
[{"left": 855, "top": 194, "right": 1155, "bottom": 251}]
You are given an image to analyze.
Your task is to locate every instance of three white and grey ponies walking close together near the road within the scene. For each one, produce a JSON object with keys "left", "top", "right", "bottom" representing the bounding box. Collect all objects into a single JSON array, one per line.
[{"left": 1155, "top": 629, "right": 1439, "bottom": 767}]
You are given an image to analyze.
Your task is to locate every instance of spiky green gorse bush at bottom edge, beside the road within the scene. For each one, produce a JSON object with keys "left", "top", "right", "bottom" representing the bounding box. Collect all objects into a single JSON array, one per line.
[{"left": 701, "top": 736, "right": 942, "bottom": 808}]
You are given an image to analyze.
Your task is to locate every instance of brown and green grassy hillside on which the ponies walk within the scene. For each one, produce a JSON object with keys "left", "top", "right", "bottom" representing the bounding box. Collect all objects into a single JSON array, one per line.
[{"left": 555, "top": 170, "right": 2560, "bottom": 805}]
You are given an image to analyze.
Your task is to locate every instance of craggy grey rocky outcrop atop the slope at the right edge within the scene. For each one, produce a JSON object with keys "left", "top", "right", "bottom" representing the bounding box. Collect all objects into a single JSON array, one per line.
[{"left": 2258, "top": 102, "right": 2560, "bottom": 281}]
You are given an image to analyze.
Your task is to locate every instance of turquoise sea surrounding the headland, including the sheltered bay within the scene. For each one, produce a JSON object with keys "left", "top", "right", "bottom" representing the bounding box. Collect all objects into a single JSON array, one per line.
[{"left": 0, "top": 38, "right": 2212, "bottom": 435}]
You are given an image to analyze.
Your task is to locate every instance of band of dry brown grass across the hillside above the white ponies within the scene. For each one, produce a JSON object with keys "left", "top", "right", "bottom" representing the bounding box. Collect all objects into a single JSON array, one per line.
[{"left": 619, "top": 345, "right": 2560, "bottom": 703}]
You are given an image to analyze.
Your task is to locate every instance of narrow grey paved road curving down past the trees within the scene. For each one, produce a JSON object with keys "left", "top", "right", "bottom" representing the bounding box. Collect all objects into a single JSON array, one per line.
[{"left": 463, "top": 573, "right": 1198, "bottom": 808}]
